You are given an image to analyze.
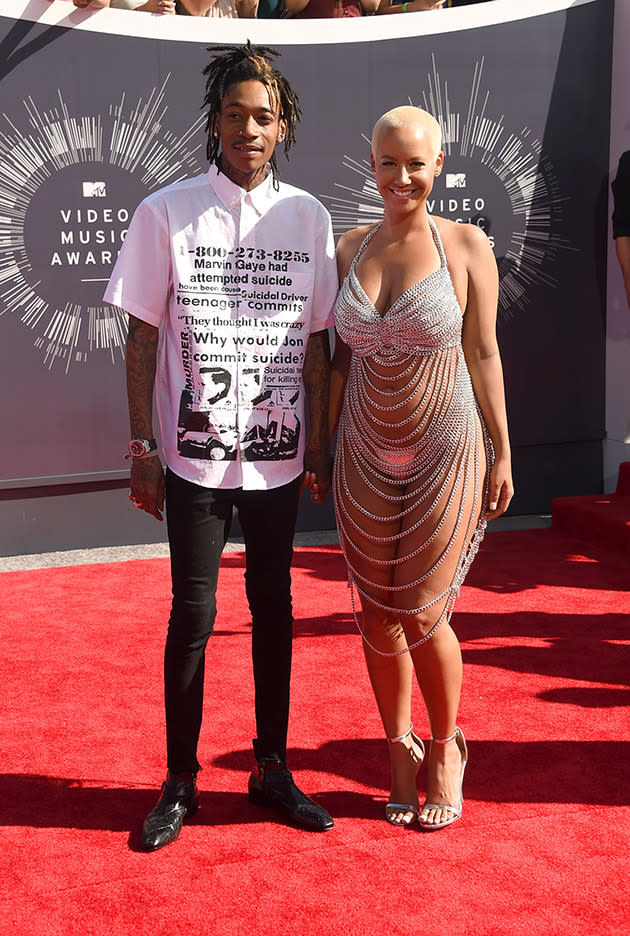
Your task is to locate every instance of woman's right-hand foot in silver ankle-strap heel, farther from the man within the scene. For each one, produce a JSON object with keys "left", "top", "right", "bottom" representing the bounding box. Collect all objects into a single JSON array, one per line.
[{"left": 418, "top": 728, "right": 468, "bottom": 832}]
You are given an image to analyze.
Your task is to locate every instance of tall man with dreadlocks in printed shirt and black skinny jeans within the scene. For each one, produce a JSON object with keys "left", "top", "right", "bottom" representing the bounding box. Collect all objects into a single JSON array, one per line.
[{"left": 105, "top": 42, "right": 337, "bottom": 850}]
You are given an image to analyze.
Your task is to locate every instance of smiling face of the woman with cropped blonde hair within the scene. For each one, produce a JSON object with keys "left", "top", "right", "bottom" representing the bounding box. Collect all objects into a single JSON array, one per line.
[{"left": 370, "top": 124, "right": 444, "bottom": 210}]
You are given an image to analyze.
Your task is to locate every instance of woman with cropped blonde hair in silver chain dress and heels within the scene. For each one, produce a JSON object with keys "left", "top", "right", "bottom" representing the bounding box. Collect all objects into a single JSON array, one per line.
[{"left": 330, "top": 107, "right": 513, "bottom": 831}]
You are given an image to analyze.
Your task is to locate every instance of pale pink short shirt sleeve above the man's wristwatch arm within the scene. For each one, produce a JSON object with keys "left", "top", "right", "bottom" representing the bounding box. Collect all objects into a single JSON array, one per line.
[{"left": 103, "top": 199, "right": 171, "bottom": 327}]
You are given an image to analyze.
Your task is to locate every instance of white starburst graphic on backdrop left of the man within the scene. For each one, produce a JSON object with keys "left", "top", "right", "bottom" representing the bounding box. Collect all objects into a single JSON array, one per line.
[{"left": 0, "top": 76, "right": 206, "bottom": 372}]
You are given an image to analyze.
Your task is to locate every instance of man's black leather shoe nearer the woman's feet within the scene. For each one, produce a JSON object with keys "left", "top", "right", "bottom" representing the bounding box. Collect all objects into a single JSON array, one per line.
[{"left": 249, "top": 757, "right": 334, "bottom": 832}]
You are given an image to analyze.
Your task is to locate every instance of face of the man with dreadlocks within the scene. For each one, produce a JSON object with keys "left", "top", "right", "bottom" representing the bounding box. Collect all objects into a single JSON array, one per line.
[{"left": 214, "top": 81, "right": 287, "bottom": 185}]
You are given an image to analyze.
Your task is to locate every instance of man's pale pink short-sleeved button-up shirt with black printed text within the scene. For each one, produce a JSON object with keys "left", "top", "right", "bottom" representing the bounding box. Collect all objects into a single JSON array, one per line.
[{"left": 105, "top": 166, "right": 337, "bottom": 490}]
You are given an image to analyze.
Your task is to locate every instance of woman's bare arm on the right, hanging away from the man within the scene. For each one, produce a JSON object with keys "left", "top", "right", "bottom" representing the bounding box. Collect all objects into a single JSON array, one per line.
[{"left": 458, "top": 224, "right": 514, "bottom": 519}]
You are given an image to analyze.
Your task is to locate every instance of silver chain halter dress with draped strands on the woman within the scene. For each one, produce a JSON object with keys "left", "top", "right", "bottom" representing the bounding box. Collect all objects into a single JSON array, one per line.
[{"left": 333, "top": 218, "right": 493, "bottom": 656}]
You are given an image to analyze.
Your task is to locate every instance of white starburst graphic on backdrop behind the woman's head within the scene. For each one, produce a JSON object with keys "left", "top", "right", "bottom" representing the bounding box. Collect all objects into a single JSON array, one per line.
[{"left": 322, "top": 56, "right": 575, "bottom": 319}]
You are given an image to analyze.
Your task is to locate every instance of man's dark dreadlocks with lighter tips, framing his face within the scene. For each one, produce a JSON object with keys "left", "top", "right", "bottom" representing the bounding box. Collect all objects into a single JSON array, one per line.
[{"left": 203, "top": 39, "right": 302, "bottom": 182}]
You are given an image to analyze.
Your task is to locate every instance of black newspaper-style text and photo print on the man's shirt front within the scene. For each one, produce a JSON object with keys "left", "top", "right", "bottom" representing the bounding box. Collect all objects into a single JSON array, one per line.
[{"left": 175, "top": 239, "right": 313, "bottom": 462}]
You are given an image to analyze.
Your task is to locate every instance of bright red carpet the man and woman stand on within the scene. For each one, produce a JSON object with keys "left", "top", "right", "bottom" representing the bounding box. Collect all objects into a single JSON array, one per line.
[{"left": 0, "top": 530, "right": 630, "bottom": 936}]
